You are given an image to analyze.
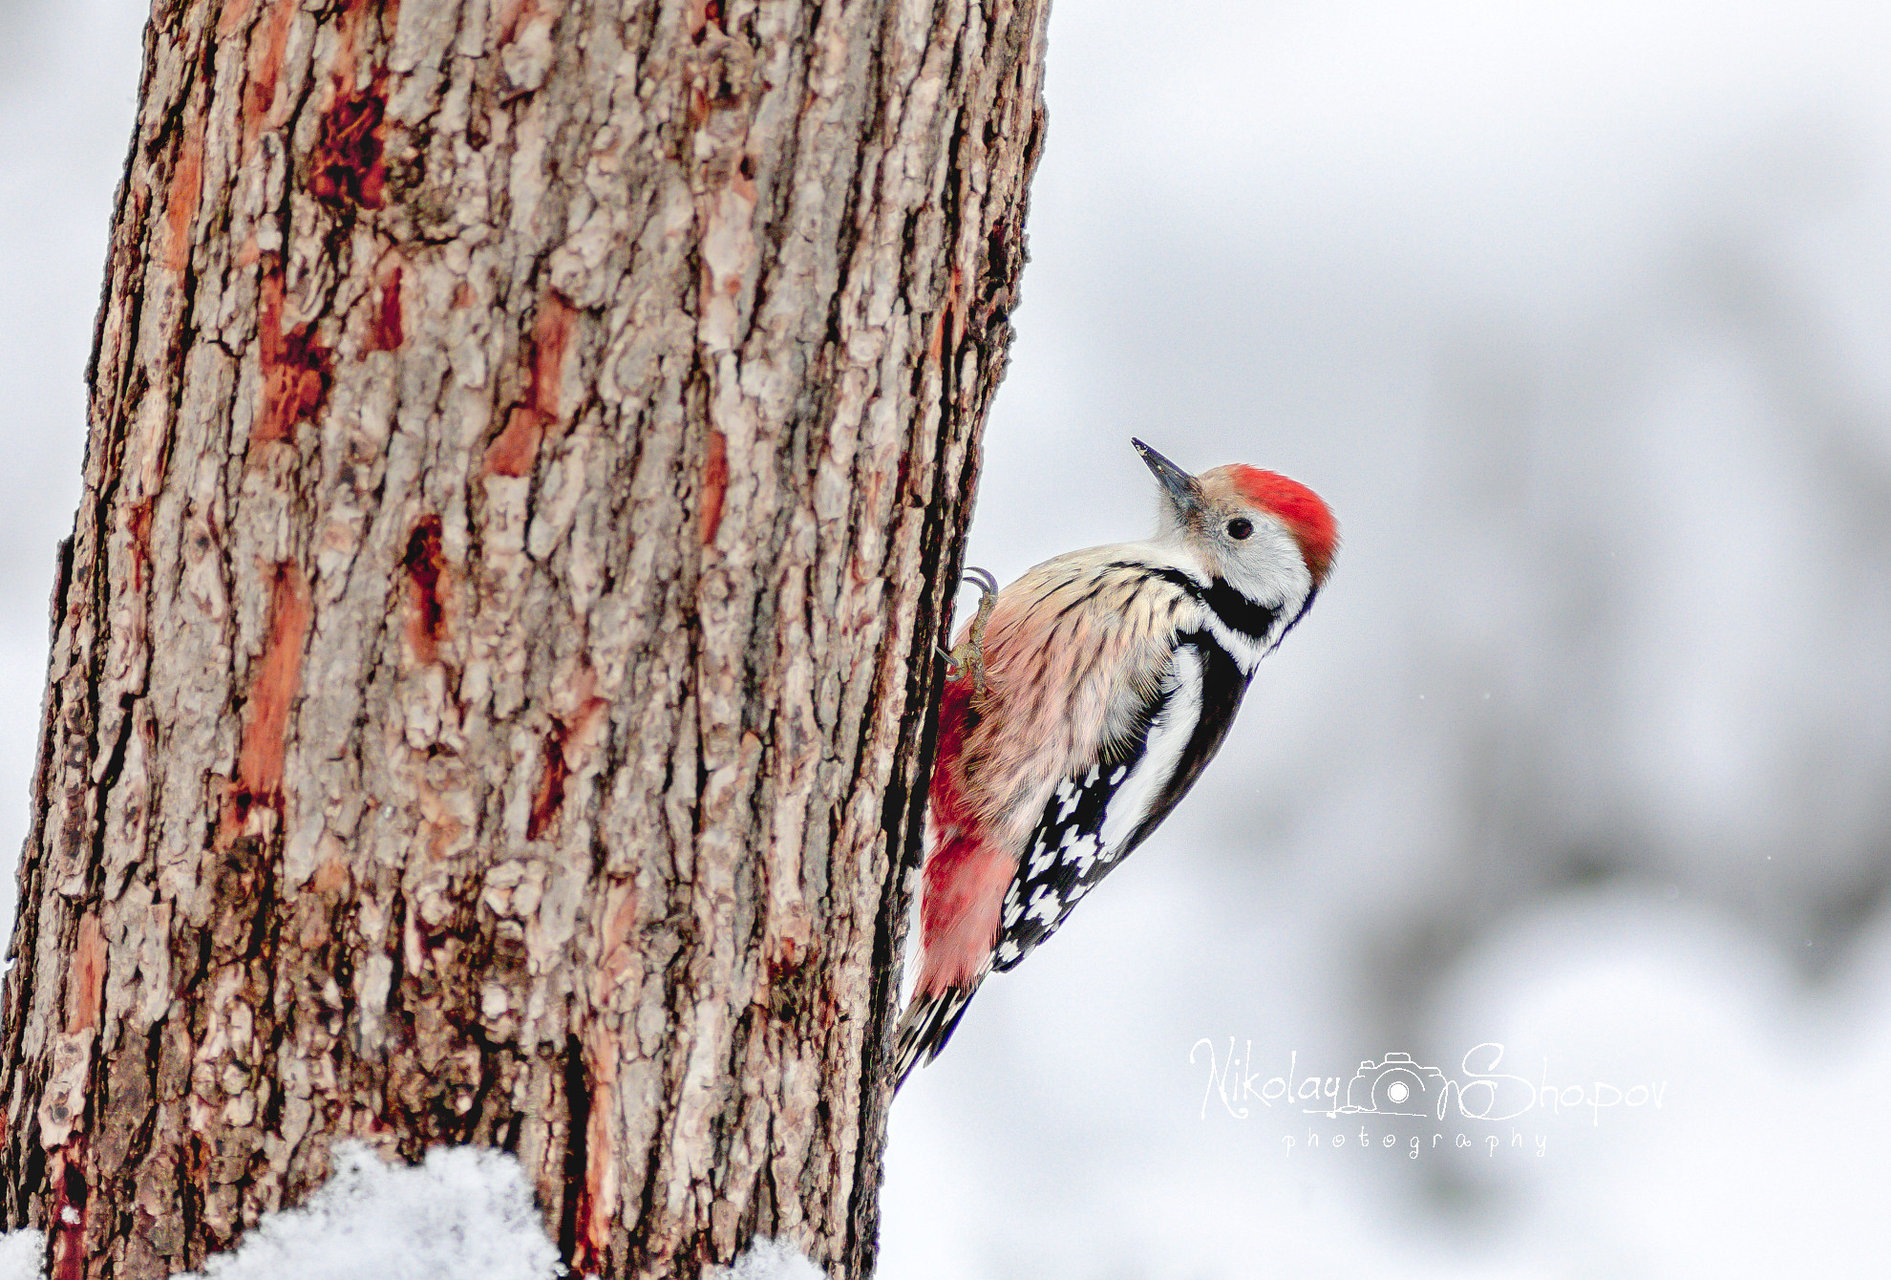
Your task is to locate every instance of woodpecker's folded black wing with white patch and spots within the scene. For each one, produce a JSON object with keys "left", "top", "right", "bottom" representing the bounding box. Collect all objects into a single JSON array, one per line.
[{"left": 993, "top": 631, "right": 1248, "bottom": 970}]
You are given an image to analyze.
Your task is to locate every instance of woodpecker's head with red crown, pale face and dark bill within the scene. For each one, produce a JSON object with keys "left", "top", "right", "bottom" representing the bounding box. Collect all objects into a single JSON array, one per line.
[{"left": 1131, "top": 441, "right": 1339, "bottom": 618}]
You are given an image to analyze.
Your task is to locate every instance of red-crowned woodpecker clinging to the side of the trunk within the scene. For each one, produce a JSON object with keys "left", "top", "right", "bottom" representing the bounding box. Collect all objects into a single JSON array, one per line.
[{"left": 896, "top": 441, "right": 1339, "bottom": 1083}]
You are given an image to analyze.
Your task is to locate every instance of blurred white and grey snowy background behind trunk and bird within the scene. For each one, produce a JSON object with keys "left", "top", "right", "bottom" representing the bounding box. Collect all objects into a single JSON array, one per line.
[{"left": 0, "top": 0, "right": 1891, "bottom": 1280}]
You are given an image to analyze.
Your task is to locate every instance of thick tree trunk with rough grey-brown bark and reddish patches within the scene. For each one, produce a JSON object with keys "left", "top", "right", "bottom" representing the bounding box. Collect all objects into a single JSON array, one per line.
[{"left": 0, "top": 0, "right": 1044, "bottom": 1276}]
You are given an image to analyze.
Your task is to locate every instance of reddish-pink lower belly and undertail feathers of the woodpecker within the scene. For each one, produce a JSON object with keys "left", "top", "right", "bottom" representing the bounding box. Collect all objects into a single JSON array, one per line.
[{"left": 915, "top": 673, "right": 1017, "bottom": 998}]
